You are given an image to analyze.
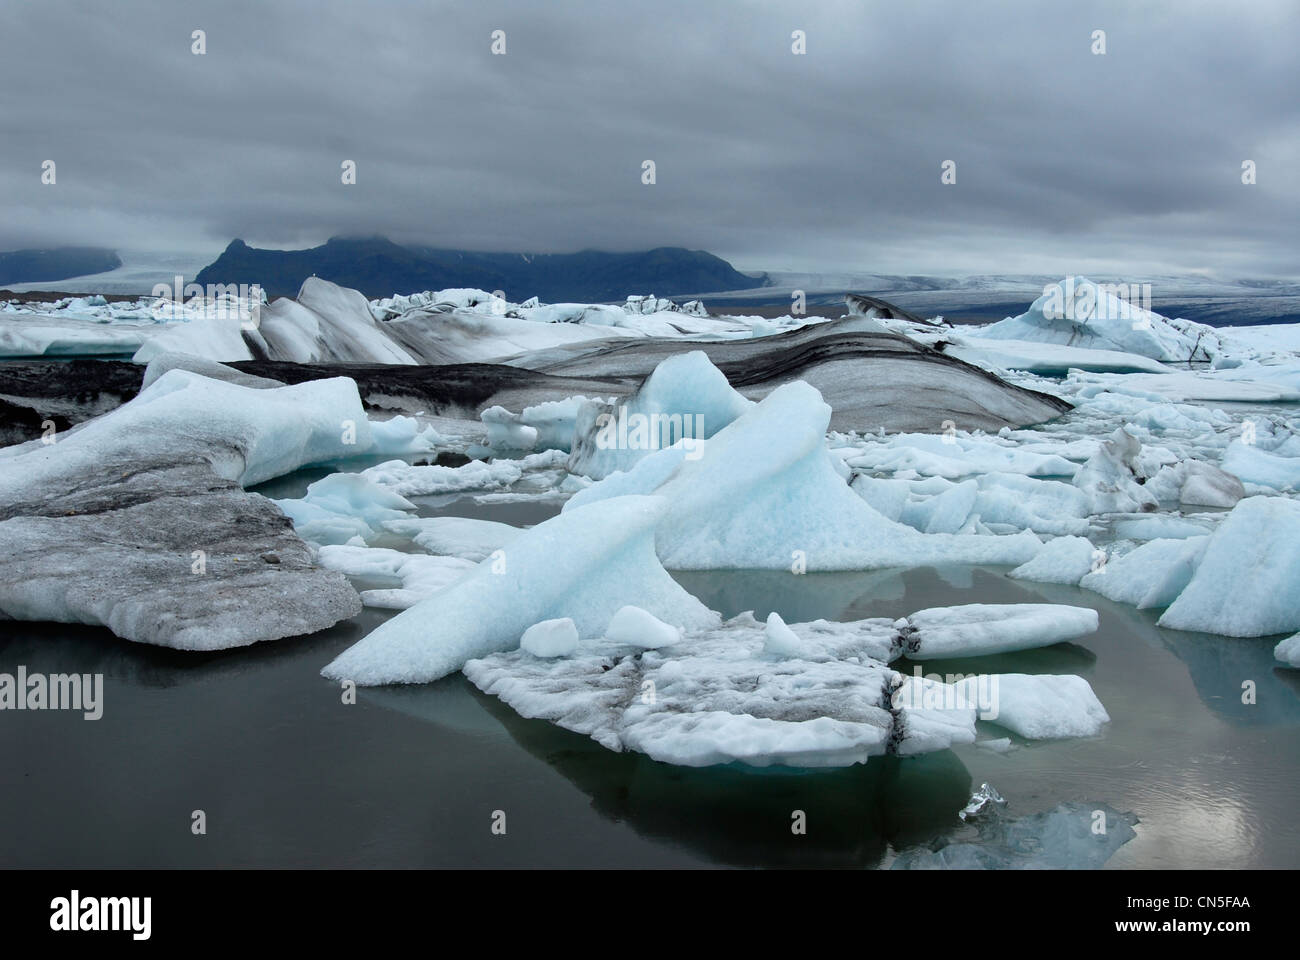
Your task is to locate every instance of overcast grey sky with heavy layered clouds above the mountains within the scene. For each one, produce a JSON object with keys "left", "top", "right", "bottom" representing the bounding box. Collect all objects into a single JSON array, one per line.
[{"left": 0, "top": 0, "right": 1300, "bottom": 277}]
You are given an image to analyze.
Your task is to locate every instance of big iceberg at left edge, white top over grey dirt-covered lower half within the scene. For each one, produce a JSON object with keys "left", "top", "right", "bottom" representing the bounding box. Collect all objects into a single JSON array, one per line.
[{"left": 0, "top": 369, "right": 371, "bottom": 650}]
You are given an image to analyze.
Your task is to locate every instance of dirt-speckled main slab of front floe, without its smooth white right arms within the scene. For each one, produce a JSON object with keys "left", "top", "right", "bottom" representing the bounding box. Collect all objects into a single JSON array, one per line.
[{"left": 465, "top": 614, "right": 975, "bottom": 767}]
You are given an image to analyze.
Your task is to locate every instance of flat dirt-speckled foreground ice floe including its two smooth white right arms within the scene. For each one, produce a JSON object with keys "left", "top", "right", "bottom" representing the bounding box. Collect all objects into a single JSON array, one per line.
[{"left": 464, "top": 604, "right": 1104, "bottom": 767}]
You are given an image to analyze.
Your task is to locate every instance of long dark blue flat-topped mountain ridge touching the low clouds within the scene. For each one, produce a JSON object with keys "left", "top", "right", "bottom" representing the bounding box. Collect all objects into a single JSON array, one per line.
[{"left": 195, "top": 237, "right": 764, "bottom": 303}]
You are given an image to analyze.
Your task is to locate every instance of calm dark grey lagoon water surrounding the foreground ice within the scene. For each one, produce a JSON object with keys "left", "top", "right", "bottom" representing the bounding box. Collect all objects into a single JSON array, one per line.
[{"left": 0, "top": 488, "right": 1300, "bottom": 868}]
